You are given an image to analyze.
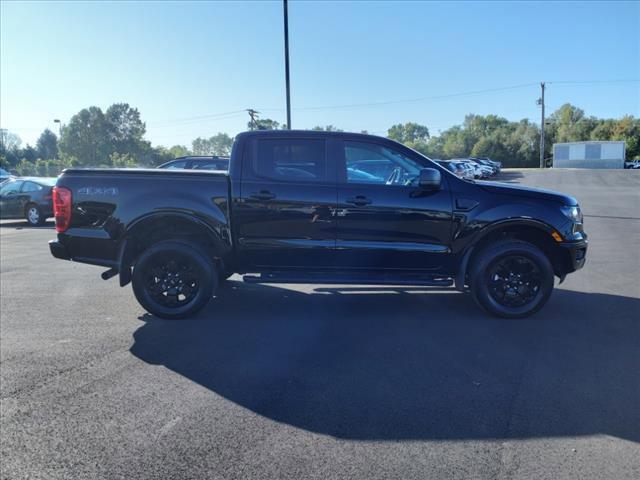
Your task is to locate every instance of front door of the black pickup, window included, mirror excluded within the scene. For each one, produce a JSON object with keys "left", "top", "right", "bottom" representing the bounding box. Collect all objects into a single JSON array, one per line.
[{"left": 336, "top": 141, "right": 452, "bottom": 271}]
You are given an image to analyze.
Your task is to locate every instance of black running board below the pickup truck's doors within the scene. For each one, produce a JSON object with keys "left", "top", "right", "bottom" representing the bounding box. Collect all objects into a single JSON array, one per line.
[{"left": 242, "top": 272, "right": 453, "bottom": 287}]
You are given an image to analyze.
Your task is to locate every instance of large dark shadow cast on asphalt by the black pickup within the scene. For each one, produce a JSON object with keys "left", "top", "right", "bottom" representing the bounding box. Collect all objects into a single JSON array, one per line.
[{"left": 131, "top": 281, "right": 640, "bottom": 442}]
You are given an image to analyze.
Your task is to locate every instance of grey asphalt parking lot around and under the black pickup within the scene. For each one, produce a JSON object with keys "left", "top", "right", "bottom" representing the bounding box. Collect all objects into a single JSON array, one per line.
[{"left": 0, "top": 170, "right": 640, "bottom": 479}]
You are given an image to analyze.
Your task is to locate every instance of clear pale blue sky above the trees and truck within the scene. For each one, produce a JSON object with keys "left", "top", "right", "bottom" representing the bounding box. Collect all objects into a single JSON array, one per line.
[{"left": 0, "top": 0, "right": 640, "bottom": 146}]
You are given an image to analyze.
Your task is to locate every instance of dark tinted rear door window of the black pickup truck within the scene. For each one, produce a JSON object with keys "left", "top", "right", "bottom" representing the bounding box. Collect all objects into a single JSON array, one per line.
[{"left": 253, "top": 139, "right": 327, "bottom": 182}]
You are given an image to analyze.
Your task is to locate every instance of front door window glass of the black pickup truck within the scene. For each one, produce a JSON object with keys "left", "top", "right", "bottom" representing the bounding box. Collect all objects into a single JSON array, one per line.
[{"left": 344, "top": 142, "right": 423, "bottom": 185}]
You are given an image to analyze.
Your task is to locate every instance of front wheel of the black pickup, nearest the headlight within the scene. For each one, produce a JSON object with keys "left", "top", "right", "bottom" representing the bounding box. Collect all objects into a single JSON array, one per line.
[{"left": 469, "top": 240, "right": 554, "bottom": 318}]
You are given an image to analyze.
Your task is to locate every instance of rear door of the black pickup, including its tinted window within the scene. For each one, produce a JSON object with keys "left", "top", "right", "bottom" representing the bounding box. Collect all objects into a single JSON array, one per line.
[{"left": 234, "top": 135, "right": 336, "bottom": 271}]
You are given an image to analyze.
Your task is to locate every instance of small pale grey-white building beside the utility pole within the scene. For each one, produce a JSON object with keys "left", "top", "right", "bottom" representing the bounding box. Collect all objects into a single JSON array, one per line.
[{"left": 553, "top": 141, "right": 625, "bottom": 168}]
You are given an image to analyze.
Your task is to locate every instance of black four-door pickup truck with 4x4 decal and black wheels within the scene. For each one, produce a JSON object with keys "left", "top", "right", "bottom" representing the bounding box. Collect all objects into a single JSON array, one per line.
[{"left": 50, "top": 131, "right": 587, "bottom": 318}]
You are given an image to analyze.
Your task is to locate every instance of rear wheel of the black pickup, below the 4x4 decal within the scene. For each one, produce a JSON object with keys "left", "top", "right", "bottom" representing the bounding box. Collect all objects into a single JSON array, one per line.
[{"left": 131, "top": 240, "right": 218, "bottom": 319}]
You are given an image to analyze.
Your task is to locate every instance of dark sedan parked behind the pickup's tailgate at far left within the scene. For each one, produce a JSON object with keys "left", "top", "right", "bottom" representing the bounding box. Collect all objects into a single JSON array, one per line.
[{"left": 0, "top": 177, "right": 56, "bottom": 226}]
